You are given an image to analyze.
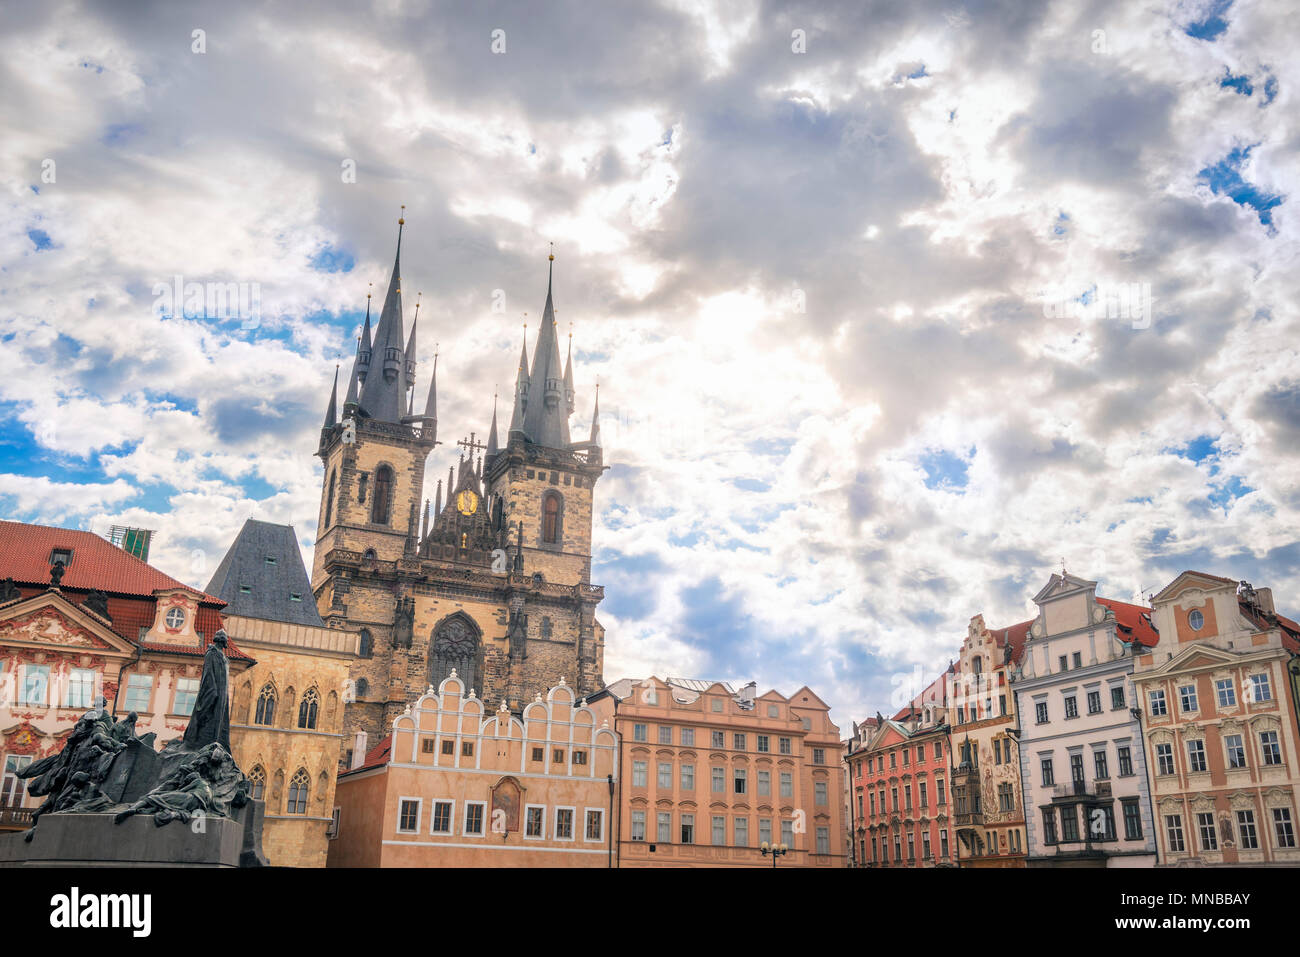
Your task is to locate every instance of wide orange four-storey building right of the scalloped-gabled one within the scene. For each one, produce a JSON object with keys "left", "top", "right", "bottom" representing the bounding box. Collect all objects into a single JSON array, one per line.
[{"left": 592, "top": 677, "right": 846, "bottom": 867}]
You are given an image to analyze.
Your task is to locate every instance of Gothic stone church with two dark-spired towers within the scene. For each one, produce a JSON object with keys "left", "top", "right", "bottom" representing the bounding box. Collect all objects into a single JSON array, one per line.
[{"left": 311, "top": 221, "right": 605, "bottom": 757}]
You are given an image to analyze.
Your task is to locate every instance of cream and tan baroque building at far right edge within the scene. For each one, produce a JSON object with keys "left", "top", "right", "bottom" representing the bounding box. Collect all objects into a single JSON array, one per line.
[{"left": 1134, "top": 571, "right": 1300, "bottom": 866}]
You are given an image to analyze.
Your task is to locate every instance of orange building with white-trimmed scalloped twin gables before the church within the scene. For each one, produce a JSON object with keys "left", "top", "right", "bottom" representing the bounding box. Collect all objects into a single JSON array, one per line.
[{"left": 328, "top": 671, "right": 619, "bottom": 867}]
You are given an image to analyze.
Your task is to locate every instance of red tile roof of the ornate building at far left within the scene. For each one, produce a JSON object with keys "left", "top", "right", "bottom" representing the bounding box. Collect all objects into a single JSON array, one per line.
[{"left": 0, "top": 521, "right": 224, "bottom": 605}]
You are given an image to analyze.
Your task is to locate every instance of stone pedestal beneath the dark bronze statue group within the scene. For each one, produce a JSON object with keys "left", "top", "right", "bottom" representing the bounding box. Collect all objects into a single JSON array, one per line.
[{"left": 0, "top": 801, "right": 267, "bottom": 867}]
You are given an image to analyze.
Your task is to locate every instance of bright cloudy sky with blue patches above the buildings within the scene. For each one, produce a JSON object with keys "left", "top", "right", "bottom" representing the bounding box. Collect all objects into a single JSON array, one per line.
[{"left": 0, "top": 0, "right": 1300, "bottom": 731}]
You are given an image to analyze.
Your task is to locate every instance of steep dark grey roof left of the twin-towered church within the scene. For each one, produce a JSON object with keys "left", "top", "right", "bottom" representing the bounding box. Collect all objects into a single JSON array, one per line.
[{"left": 208, "top": 519, "right": 325, "bottom": 628}]
